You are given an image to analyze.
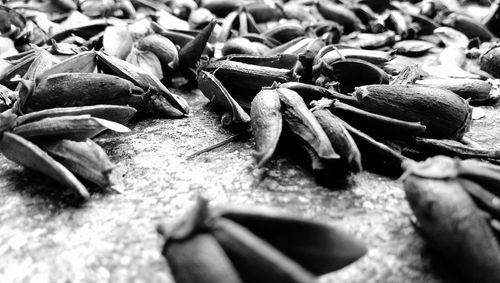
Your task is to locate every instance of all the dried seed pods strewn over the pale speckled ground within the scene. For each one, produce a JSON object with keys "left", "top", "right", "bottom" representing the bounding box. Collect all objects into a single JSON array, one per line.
[{"left": 0, "top": 0, "right": 500, "bottom": 282}]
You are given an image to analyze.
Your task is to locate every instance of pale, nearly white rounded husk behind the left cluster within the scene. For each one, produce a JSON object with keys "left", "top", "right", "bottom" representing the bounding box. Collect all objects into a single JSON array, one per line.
[{"left": 102, "top": 26, "right": 134, "bottom": 60}]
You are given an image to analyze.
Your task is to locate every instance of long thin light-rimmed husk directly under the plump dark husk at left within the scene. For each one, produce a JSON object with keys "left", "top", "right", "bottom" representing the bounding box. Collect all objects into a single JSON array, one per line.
[{"left": 16, "top": 104, "right": 137, "bottom": 125}]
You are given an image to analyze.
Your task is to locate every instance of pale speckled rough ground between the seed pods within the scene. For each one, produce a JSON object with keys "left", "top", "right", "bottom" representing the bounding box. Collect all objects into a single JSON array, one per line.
[{"left": 0, "top": 87, "right": 500, "bottom": 283}]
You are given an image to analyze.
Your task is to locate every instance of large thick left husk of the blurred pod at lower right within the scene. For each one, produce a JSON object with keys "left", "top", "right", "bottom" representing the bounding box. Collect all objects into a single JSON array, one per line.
[{"left": 403, "top": 157, "right": 500, "bottom": 282}]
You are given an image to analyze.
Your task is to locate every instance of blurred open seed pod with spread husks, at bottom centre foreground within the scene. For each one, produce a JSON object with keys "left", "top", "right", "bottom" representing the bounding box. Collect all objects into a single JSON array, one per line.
[{"left": 158, "top": 198, "right": 366, "bottom": 283}]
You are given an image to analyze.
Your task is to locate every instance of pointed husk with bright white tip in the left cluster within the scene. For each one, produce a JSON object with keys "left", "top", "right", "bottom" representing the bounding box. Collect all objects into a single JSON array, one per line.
[{"left": 13, "top": 115, "right": 130, "bottom": 140}]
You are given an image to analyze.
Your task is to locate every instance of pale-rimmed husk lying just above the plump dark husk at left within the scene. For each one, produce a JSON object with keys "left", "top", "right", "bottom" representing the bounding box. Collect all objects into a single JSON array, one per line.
[{"left": 36, "top": 50, "right": 96, "bottom": 84}]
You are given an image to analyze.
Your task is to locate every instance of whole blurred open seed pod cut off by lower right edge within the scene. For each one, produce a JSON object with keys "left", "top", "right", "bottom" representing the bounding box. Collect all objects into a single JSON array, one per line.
[{"left": 402, "top": 156, "right": 500, "bottom": 283}]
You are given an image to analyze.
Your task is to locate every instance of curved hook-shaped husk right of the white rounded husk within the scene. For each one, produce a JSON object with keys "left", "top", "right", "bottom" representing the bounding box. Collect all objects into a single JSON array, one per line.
[{"left": 137, "top": 34, "right": 179, "bottom": 75}]
